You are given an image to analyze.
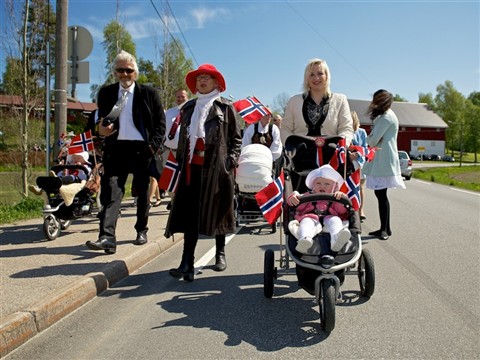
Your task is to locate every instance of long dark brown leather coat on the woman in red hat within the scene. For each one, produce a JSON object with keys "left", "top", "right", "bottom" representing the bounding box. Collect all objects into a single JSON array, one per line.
[{"left": 165, "top": 98, "right": 242, "bottom": 237}]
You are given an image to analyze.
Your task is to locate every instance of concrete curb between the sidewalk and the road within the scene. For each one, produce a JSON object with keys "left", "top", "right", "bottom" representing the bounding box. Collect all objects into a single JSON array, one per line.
[{"left": 0, "top": 236, "right": 183, "bottom": 358}]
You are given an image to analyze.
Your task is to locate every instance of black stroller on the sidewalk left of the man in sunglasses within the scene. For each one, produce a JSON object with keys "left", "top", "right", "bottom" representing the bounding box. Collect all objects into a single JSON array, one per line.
[{"left": 36, "top": 165, "right": 99, "bottom": 240}]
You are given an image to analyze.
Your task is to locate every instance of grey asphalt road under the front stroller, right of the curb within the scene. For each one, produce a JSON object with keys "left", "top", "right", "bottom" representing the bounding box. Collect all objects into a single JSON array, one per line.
[{"left": 6, "top": 180, "right": 480, "bottom": 359}]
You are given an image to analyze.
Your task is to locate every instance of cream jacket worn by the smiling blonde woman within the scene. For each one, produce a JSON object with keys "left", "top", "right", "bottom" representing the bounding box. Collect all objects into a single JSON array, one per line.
[{"left": 280, "top": 93, "right": 353, "bottom": 146}]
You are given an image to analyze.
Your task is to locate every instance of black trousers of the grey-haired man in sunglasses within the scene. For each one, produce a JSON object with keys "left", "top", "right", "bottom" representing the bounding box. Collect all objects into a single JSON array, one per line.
[{"left": 99, "top": 140, "right": 152, "bottom": 241}]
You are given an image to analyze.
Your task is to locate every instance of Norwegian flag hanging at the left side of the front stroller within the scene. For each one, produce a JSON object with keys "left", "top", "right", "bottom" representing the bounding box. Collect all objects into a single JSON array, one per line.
[{"left": 255, "top": 169, "right": 285, "bottom": 225}]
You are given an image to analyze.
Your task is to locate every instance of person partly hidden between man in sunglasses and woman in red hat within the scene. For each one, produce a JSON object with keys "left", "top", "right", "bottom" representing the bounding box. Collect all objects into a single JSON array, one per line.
[{"left": 161, "top": 88, "right": 188, "bottom": 210}]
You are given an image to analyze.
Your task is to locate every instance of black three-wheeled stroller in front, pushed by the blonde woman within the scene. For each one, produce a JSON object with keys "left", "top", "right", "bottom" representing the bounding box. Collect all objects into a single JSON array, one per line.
[{"left": 264, "top": 135, "right": 375, "bottom": 332}]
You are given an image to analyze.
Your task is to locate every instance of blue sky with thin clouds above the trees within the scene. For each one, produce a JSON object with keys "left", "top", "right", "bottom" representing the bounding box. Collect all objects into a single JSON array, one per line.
[{"left": 0, "top": 0, "right": 480, "bottom": 107}]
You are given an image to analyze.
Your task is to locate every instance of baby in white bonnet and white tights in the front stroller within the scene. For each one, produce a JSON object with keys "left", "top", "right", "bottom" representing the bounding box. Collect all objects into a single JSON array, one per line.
[{"left": 287, "top": 164, "right": 351, "bottom": 255}]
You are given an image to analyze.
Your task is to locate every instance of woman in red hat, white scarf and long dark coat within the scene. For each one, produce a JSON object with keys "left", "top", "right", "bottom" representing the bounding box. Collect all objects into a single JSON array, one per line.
[{"left": 165, "top": 64, "right": 242, "bottom": 281}]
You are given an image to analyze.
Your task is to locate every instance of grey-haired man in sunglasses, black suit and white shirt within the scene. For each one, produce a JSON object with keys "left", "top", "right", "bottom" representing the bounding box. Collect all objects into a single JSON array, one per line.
[{"left": 86, "top": 50, "right": 165, "bottom": 254}]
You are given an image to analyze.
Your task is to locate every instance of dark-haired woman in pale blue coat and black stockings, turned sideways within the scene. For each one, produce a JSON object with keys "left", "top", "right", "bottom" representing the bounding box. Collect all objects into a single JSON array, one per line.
[{"left": 363, "top": 89, "right": 405, "bottom": 240}]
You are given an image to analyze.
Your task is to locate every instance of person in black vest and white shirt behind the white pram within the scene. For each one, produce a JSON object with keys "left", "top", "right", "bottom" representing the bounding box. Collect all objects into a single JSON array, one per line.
[{"left": 242, "top": 115, "right": 283, "bottom": 177}]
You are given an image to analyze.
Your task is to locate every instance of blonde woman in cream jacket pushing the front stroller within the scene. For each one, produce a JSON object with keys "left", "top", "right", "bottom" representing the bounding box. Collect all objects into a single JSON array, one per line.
[{"left": 280, "top": 59, "right": 353, "bottom": 146}]
